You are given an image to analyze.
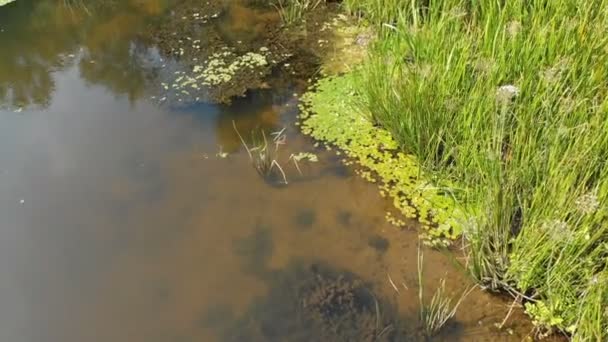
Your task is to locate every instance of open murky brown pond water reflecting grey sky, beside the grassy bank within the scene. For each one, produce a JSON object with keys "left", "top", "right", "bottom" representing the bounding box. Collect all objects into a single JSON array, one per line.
[{"left": 0, "top": 0, "right": 530, "bottom": 342}]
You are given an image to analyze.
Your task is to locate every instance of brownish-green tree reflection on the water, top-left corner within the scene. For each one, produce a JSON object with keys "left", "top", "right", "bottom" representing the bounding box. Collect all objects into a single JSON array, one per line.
[{"left": 0, "top": 0, "right": 167, "bottom": 108}]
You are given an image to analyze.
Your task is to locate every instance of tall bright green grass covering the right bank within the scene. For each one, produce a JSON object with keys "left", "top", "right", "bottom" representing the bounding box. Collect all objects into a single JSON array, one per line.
[{"left": 344, "top": 0, "right": 608, "bottom": 341}]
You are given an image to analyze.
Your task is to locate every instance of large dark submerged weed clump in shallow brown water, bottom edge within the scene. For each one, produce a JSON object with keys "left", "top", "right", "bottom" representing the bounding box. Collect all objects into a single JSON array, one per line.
[{"left": 201, "top": 261, "right": 414, "bottom": 341}]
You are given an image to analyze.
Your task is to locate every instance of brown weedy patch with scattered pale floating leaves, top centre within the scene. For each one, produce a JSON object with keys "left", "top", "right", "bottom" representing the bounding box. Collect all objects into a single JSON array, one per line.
[{"left": 141, "top": 0, "right": 350, "bottom": 106}]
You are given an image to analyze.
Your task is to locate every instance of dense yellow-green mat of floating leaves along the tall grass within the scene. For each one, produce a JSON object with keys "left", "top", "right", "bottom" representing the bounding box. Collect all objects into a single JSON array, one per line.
[{"left": 299, "top": 71, "right": 464, "bottom": 246}]
